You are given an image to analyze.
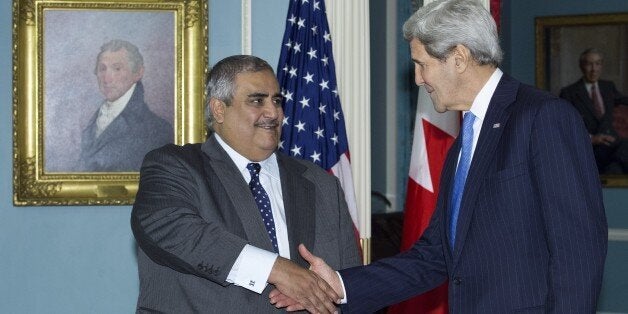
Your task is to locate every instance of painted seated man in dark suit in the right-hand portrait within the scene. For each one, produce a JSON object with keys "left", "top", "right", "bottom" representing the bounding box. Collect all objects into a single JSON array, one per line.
[{"left": 560, "top": 48, "right": 628, "bottom": 174}]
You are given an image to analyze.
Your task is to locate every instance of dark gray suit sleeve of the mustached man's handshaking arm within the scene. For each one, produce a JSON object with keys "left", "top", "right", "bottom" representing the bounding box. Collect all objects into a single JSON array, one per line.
[{"left": 131, "top": 145, "right": 247, "bottom": 286}]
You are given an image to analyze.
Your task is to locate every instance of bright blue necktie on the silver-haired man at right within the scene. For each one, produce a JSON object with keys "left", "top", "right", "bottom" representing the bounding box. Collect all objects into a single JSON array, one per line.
[{"left": 449, "top": 111, "right": 475, "bottom": 250}]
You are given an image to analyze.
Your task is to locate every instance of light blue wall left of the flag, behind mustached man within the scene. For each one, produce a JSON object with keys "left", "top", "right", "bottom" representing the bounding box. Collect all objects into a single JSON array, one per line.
[{"left": 0, "top": 0, "right": 288, "bottom": 314}]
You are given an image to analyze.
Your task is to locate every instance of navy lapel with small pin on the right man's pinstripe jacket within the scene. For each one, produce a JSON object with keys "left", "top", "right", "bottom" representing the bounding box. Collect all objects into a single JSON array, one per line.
[{"left": 453, "top": 74, "right": 519, "bottom": 267}]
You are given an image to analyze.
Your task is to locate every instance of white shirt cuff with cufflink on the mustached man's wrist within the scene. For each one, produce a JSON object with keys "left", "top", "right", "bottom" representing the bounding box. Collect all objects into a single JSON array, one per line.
[{"left": 227, "top": 244, "right": 278, "bottom": 294}]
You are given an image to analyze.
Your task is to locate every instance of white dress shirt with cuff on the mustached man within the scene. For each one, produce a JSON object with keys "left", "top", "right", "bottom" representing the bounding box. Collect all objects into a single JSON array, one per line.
[{"left": 214, "top": 134, "right": 290, "bottom": 293}]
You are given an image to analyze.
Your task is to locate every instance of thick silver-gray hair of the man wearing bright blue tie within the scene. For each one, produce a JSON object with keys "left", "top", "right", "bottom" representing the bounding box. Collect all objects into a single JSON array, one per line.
[{"left": 403, "top": 0, "right": 503, "bottom": 66}]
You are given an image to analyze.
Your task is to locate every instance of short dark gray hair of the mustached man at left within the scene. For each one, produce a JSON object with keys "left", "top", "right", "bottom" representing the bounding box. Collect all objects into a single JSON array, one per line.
[{"left": 205, "top": 55, "right": 275, "bottom": 133}]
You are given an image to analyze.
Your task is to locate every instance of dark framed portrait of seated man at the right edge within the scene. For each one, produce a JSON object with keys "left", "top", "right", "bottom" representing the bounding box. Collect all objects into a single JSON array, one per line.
[{"left": 536, "top": 13, "right": 628, "bottom": 187}]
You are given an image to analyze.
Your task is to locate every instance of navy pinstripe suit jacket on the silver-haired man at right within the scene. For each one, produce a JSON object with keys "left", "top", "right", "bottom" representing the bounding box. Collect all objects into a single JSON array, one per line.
[{"left": 341, "top": 75, "right": 607, "bottom": 313}]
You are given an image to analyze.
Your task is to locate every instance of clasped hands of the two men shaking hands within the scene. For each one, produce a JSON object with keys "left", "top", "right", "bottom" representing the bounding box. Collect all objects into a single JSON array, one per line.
[{"left": 268, "top": 244, "right": 344, "bottom": 313}]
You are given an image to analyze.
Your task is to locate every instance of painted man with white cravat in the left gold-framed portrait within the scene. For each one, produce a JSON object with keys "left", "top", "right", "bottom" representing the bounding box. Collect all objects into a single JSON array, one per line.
[{"left": 79, "top": 39, "right": 174, "bottom": 172}]
